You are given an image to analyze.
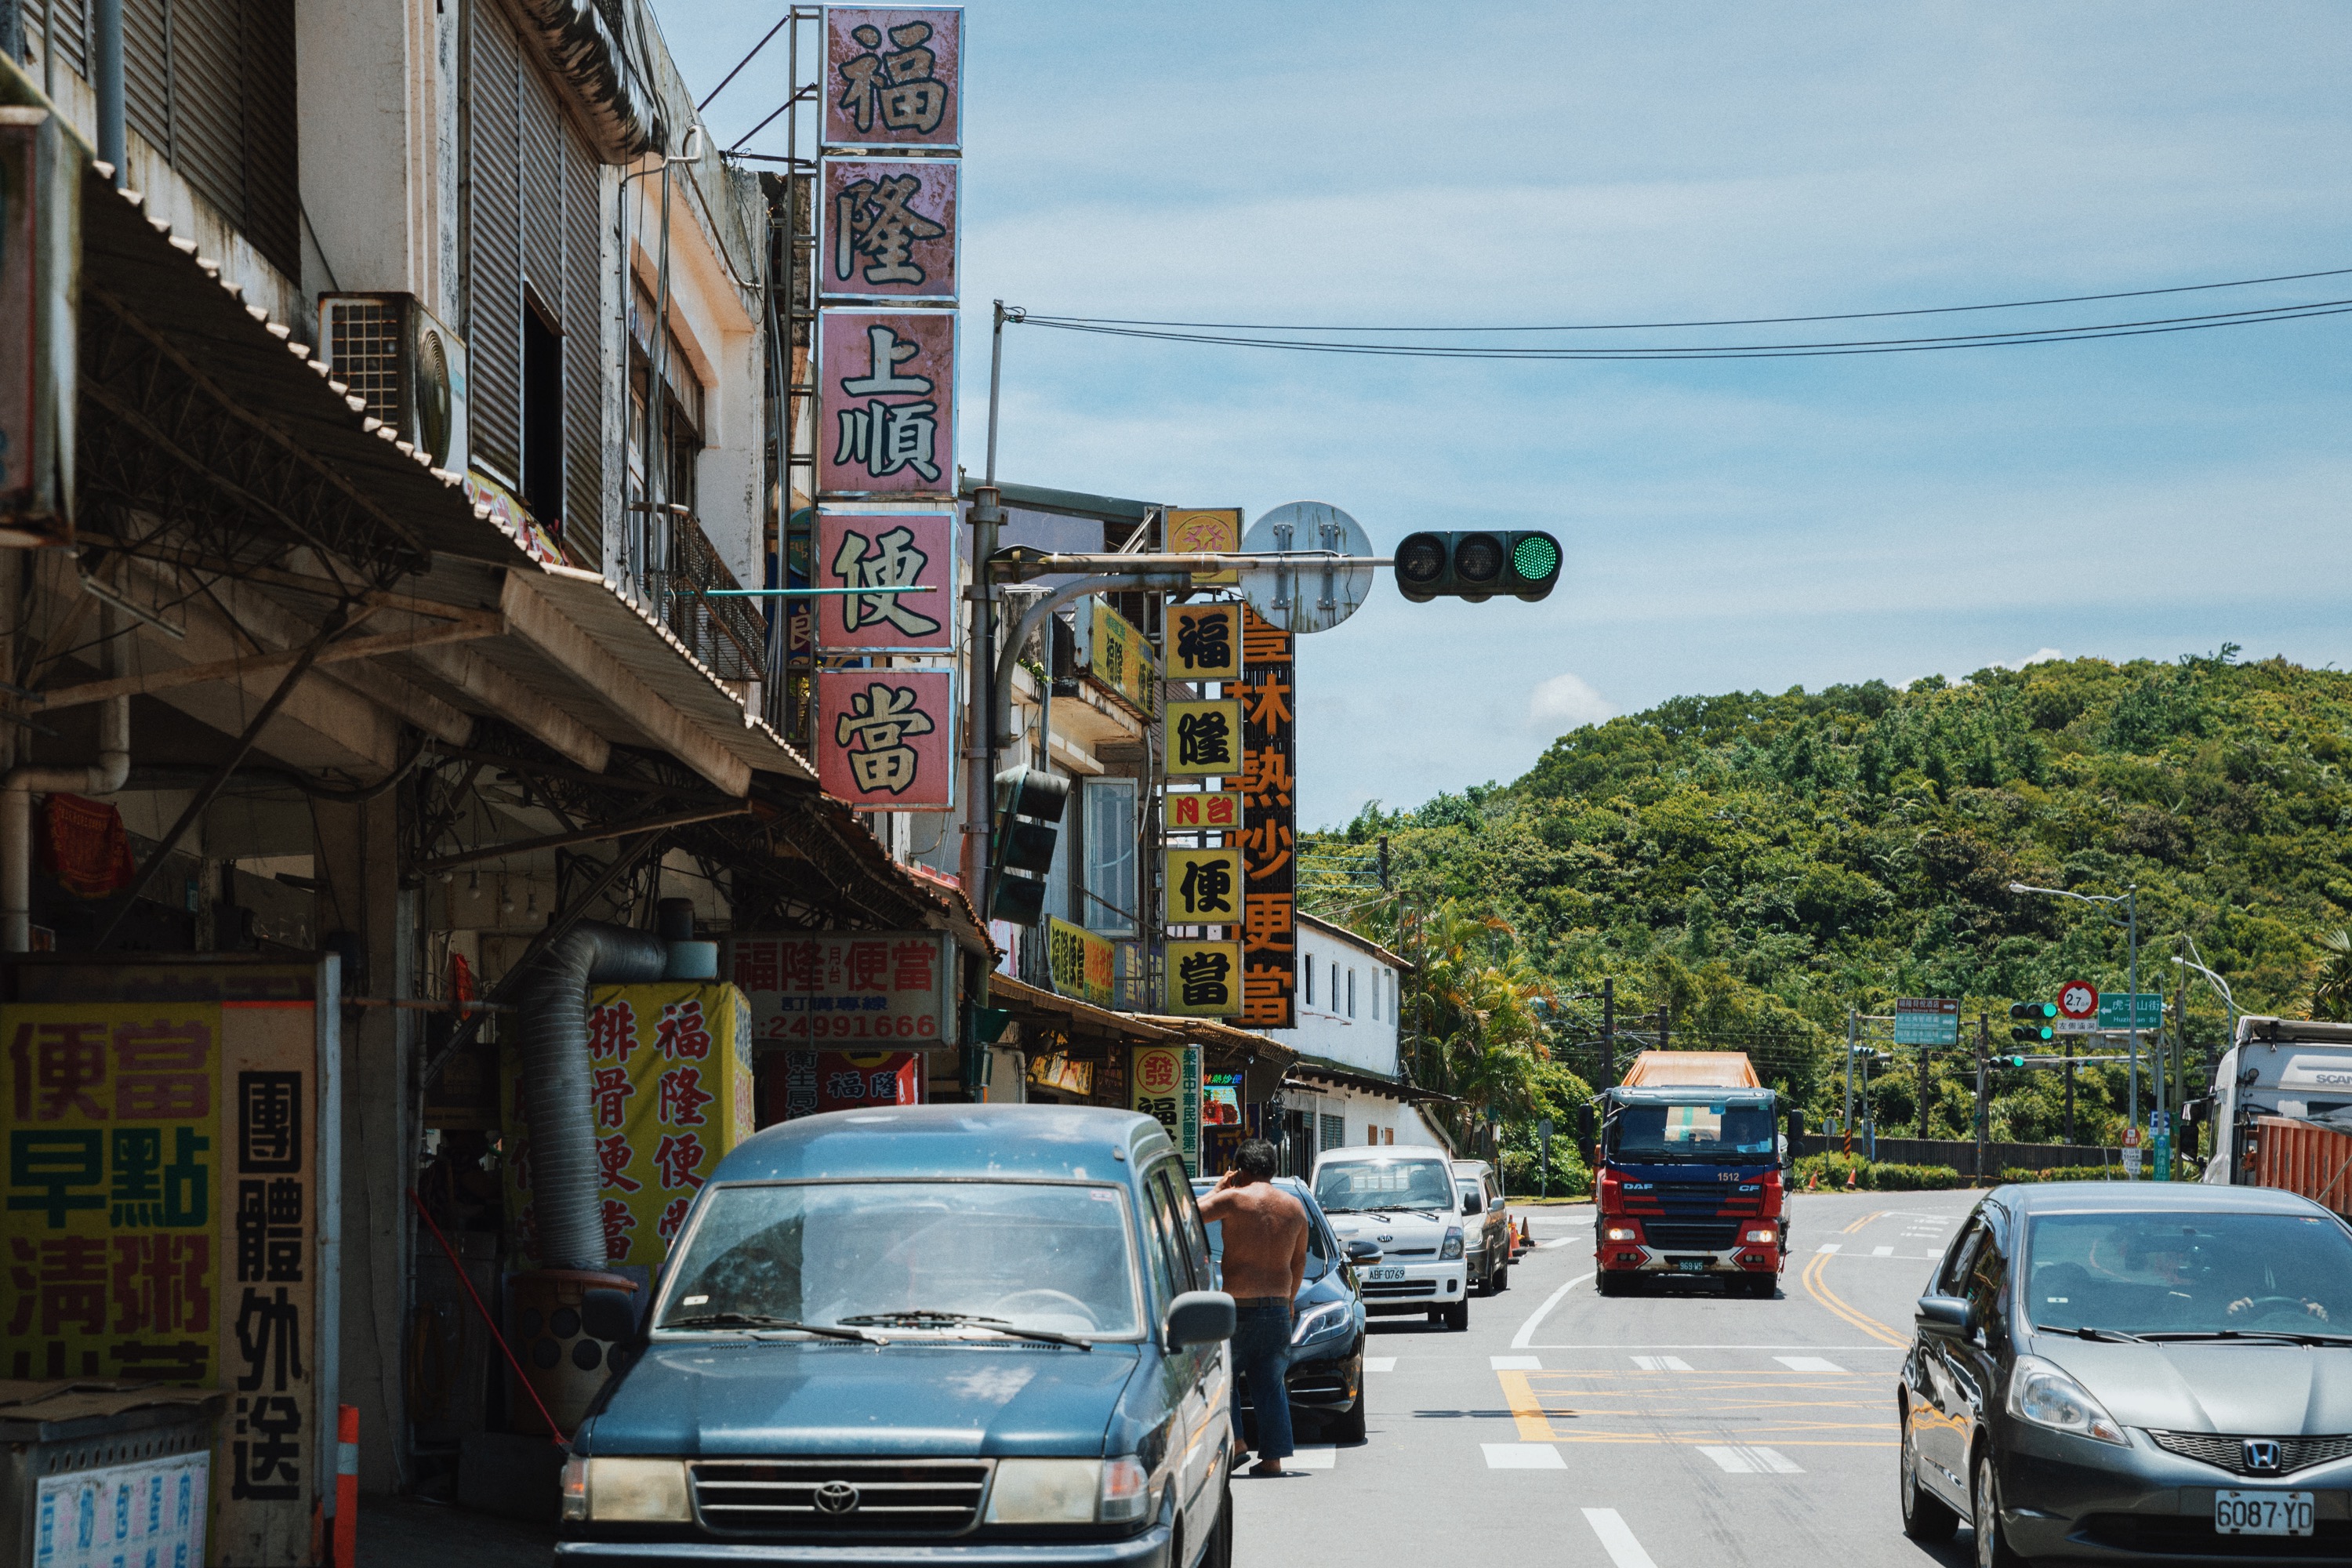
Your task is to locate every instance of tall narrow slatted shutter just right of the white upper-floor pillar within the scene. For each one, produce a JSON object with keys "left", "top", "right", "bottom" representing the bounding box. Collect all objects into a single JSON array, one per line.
[{"left": 466, "top": 5, "right": 522, "bottom": 485}]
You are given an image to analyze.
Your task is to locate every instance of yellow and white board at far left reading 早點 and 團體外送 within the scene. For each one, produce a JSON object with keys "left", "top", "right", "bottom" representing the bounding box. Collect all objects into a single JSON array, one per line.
[{"left": 0, "top": 1001, "right": 334, "bottom": 1561}]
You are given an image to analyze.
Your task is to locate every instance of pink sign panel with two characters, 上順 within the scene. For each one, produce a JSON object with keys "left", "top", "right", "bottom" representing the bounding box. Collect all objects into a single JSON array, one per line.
[{"left": 816, "top": 310, "right": 955, "bottom": 499}]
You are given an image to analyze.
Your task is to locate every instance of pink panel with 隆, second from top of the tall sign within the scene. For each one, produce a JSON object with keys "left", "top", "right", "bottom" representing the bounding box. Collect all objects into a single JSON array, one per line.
[{"left": 816, "top": 158, "right": 962, "bottom": 306}]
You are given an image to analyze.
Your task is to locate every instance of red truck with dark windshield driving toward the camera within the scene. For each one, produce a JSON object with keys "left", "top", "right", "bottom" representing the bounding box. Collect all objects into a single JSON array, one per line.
[{"left": 1592, "top": 1051, "right": 1788, "bottom": 1298}]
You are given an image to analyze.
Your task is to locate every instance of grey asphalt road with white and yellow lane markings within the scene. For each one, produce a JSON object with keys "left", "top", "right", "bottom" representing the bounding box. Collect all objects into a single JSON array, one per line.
[{"left": 1232, "top": 1192, "right": 1978, "bottom": 1568}]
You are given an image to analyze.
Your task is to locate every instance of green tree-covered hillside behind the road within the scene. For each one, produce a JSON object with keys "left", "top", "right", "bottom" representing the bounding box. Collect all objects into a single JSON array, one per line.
[{"left": 1301, "top": 647, "right": 2352, "bottom": 1142}]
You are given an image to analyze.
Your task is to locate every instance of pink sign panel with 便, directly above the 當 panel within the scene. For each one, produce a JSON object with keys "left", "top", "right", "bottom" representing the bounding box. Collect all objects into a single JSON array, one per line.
[{"left": 811, "top": 508, "right": 955, "bottom": 654}]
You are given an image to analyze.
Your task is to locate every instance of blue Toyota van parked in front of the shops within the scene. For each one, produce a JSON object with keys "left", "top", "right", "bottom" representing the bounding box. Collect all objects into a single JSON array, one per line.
[{"left": 555, "top": 1105, "right": 1232, "bottom": 1568}]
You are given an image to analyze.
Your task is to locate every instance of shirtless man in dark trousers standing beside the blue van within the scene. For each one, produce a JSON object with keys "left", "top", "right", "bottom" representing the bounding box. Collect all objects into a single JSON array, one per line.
[{"left": 1200, "top": 1138, "right": 1308, "bottom": 1476}]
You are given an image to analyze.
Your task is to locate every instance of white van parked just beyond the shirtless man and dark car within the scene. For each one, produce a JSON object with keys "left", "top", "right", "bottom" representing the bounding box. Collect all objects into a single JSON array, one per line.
[{"left": 1315, "top": 1145, "right": 1470, "bottom": 1330}]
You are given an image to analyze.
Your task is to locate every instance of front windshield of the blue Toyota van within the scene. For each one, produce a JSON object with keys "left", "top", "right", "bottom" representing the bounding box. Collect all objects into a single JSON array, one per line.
[{"left": 661, "top": 1182, "right": 1138, "bottom": 1338}]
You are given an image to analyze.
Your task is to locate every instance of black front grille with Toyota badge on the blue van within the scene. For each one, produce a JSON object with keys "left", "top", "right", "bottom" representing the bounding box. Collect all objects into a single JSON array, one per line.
[{"left": 689, "top": 1460, "right": 990, "bottom": 1535}]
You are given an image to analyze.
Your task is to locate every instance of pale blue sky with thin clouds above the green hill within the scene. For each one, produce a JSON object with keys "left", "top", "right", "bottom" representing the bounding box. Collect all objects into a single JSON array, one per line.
[{"left": 656, "top": 0, "right": 2352, "bottom": 825}]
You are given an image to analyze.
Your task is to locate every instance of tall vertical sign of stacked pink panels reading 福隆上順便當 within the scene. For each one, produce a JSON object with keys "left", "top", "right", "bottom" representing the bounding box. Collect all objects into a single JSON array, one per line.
[{"left": 809, "top": 5, "right": 964, "bottom": 811}]
